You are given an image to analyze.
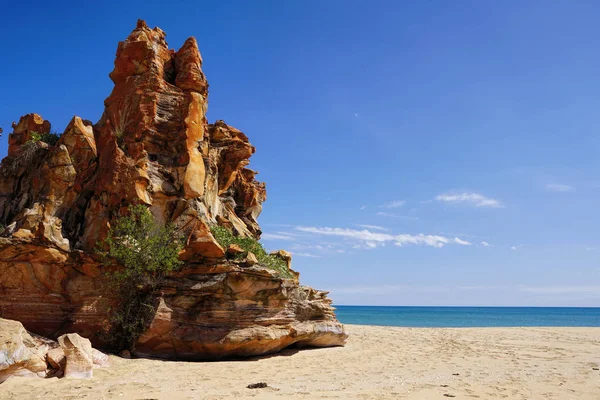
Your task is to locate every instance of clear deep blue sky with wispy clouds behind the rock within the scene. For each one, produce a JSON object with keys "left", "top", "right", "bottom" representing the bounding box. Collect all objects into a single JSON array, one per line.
[{"left": 0, "top": 0, "right": 600, "bottom": 306}]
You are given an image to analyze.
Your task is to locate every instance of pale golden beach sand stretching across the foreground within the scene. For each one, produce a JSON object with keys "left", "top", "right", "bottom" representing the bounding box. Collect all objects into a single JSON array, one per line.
[{"left": 0, "top": 325, "right": 600, "bottom": 400}]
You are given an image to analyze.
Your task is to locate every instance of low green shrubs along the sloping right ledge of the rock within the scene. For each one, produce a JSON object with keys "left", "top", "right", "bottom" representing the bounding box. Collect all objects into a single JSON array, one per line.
[{"left": 210, "top": 225, "right": 292, "bottom": 278}]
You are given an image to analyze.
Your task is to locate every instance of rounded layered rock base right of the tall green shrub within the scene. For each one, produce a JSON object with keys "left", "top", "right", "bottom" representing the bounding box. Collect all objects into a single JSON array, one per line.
[{"left": 136, "top": 264, "right": 345, "bottom": 360}]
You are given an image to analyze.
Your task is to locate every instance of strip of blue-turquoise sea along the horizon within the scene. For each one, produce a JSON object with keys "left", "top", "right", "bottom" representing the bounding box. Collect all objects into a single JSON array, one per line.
[{"left": 335, "top": 306, "right": 600, "bottom": 328}]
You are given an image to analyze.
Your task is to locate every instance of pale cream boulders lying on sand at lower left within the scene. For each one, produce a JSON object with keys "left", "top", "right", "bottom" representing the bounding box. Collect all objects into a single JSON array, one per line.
[{"left": 0, "top": 318, "right": 109, "bottom": 383}]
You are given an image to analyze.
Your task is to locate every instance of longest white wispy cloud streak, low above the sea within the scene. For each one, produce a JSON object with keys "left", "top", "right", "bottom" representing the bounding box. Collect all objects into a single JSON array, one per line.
[{"left": 296, "top": 226, "right": 470, "bottom": 248}]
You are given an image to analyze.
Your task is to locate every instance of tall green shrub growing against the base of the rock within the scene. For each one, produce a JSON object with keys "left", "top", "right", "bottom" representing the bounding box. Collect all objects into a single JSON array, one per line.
[{"left": 97, "top": 205, "right": 182, "bottom": 350}]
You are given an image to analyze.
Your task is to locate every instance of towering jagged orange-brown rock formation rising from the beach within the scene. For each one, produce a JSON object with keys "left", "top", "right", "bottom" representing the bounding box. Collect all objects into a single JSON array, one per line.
[{"left": 0, "top": 21, "right": 347, "bottom": 359}]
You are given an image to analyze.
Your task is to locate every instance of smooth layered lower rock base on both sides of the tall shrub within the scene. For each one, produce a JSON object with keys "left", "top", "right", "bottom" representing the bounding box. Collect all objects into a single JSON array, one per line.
[{"left": 0, "top": 238, "right": 348, "bottom": 360}]
